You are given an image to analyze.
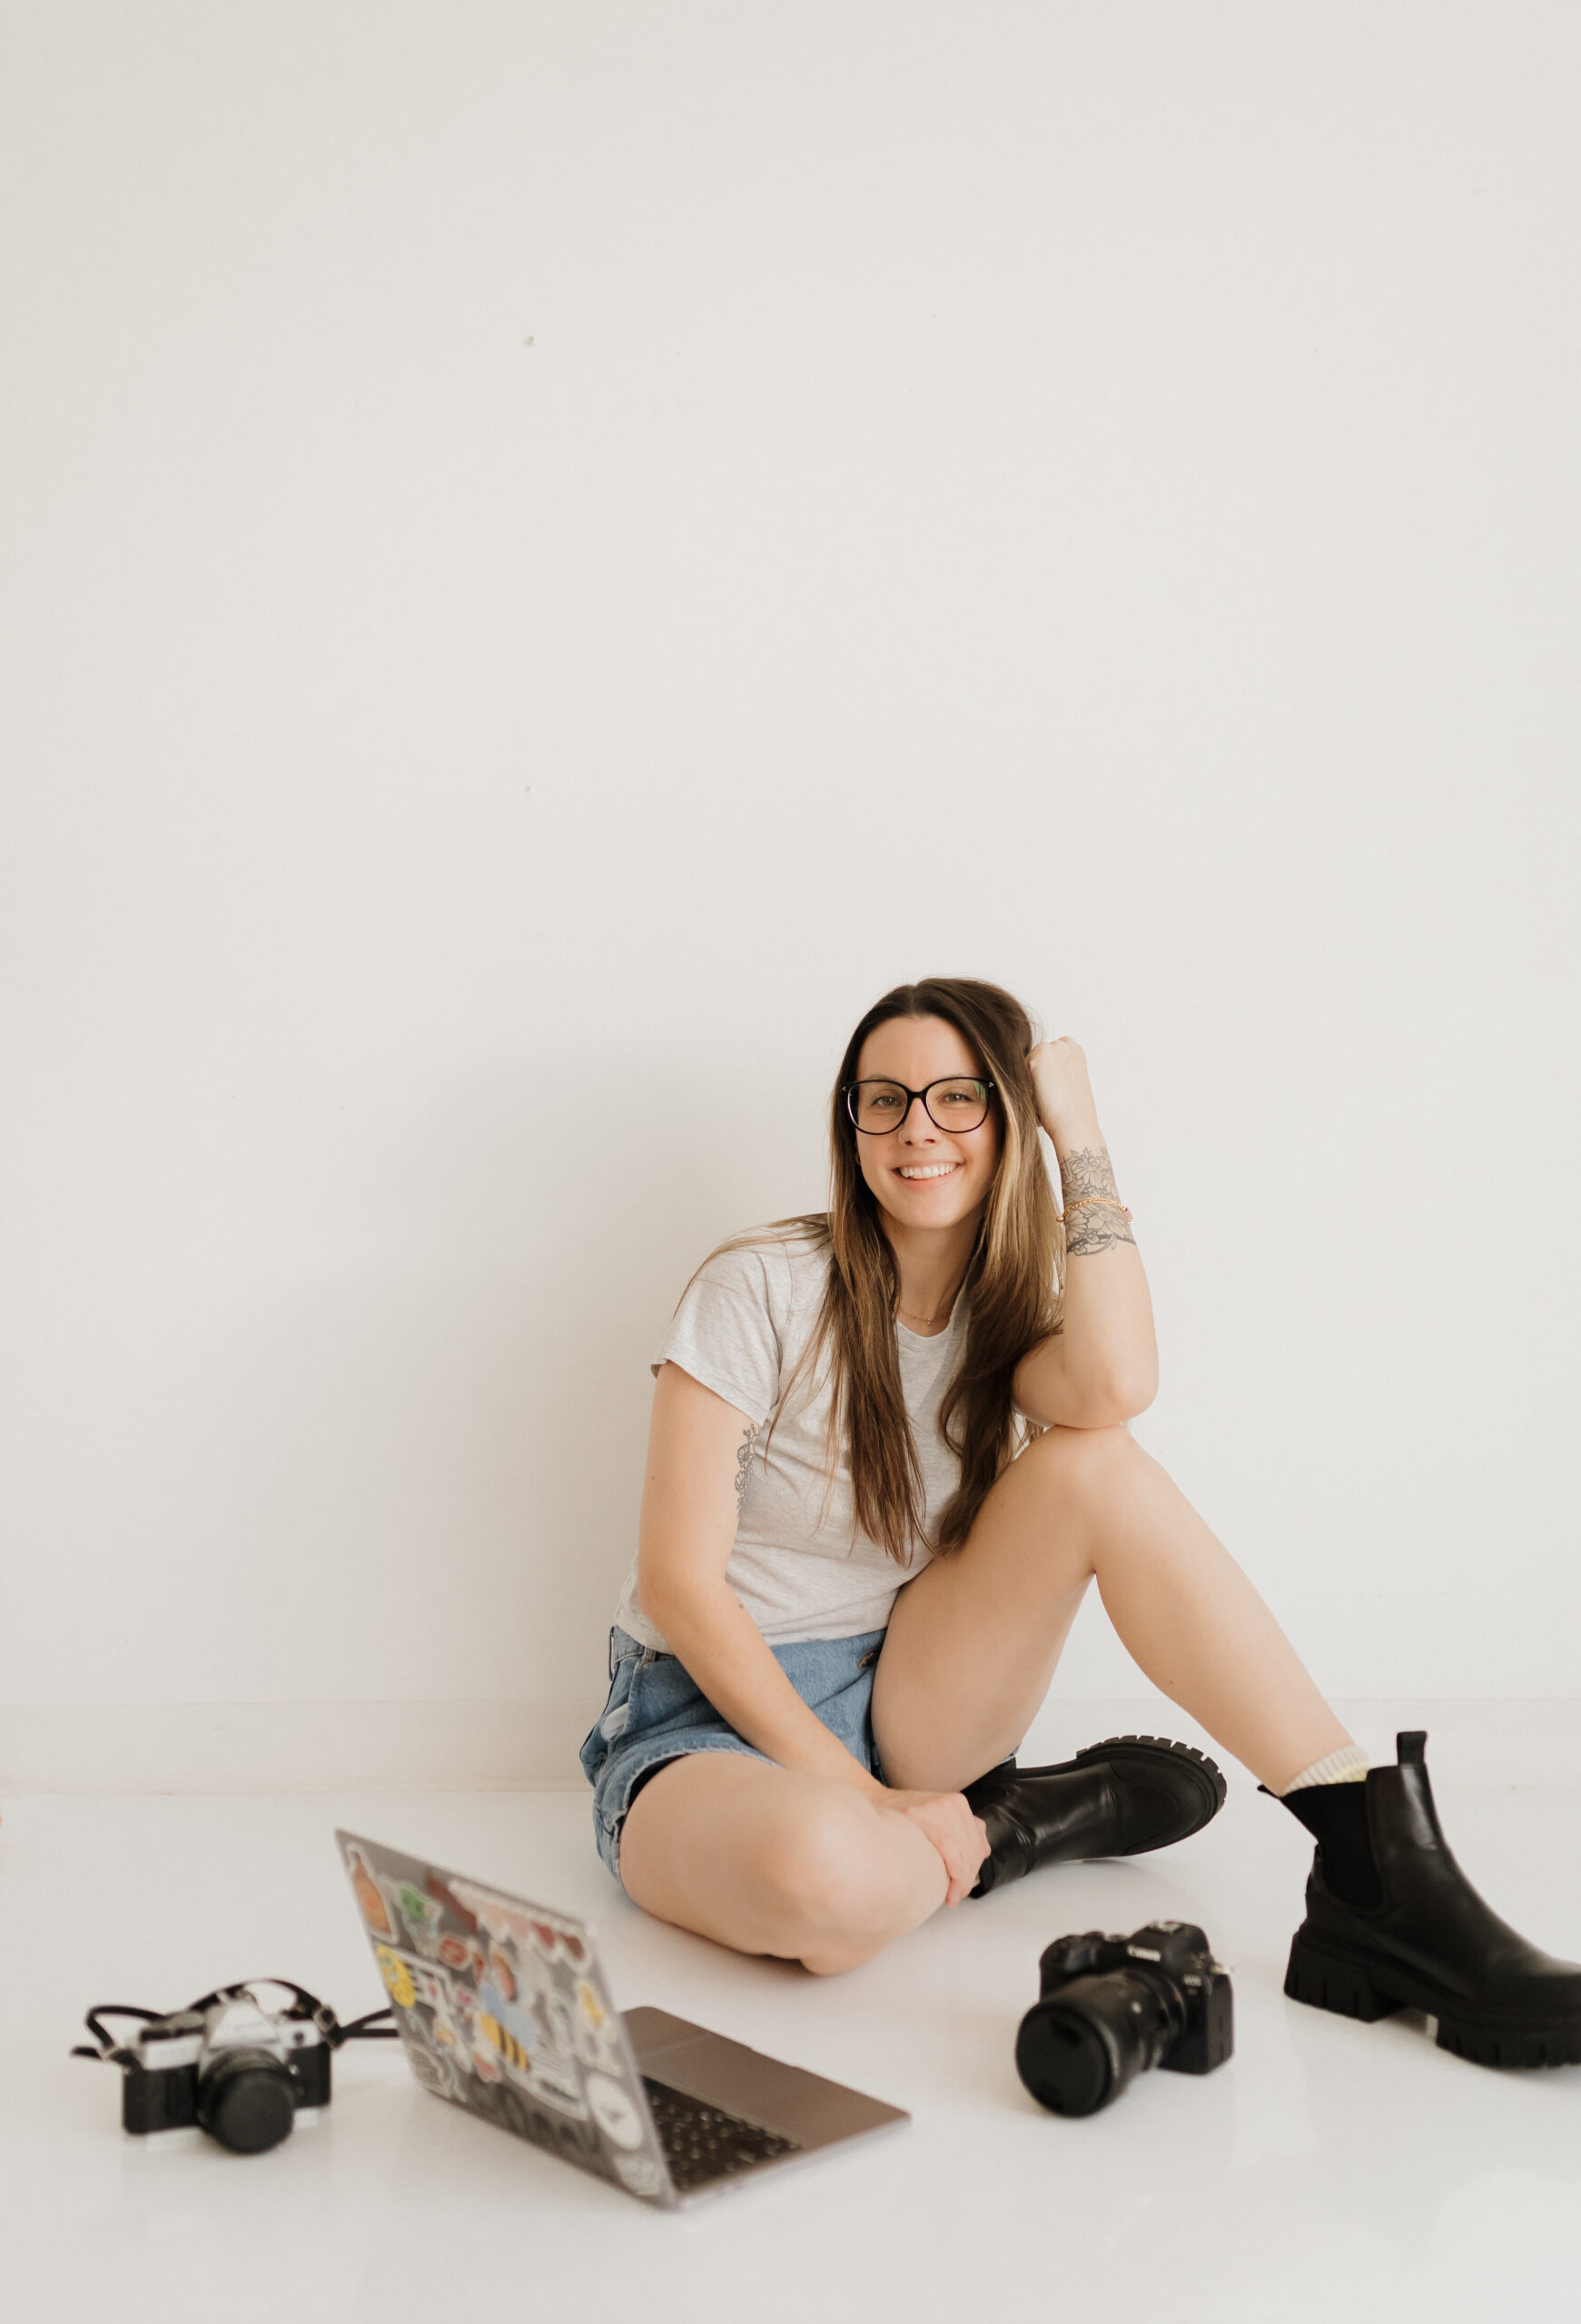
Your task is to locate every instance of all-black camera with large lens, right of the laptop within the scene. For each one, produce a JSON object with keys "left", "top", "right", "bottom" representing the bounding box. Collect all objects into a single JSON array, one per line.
[{"left": 1016, "top": 1920, "right": 1235, "bottom": 2115}]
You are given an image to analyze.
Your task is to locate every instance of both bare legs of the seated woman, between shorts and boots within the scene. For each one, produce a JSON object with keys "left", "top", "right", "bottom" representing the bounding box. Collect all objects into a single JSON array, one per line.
[{"left": 621, "top": 1429, "right": 1351, "bottom": 1973}]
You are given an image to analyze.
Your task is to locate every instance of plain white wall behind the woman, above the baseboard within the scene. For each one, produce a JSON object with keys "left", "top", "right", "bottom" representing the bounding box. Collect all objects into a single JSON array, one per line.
[{"left": 0, "top": 0, "right": 1581, "bottom": 1780}]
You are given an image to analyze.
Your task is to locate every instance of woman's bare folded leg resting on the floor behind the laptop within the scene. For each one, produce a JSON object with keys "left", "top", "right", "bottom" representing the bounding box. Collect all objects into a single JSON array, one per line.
[{"left": 621, "top": 1750, "right": 949, "bottom": 1975}]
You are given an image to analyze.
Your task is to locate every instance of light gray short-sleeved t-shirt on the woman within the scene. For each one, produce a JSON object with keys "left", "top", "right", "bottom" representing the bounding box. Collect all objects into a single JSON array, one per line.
[{"left": 616, "top": 1236, "right": 967, "bottom": 1648}]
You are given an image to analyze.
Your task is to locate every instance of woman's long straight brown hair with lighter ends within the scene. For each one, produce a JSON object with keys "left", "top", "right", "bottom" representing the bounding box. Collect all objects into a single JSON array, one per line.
[{"left": 723, "top": 976, "right": 1065, "bottom": 1564}]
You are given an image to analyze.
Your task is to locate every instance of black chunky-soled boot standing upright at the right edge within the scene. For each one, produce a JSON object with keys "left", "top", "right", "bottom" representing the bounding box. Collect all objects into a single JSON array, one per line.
[{"left": 1283, "top": 1734, "right": 1581, "bottom": 2066}]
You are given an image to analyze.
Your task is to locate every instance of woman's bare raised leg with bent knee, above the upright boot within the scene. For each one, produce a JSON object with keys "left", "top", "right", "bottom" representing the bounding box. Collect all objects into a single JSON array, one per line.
[{"left": 872, "top": 1427, "right": 1351, "bottom": 1792}]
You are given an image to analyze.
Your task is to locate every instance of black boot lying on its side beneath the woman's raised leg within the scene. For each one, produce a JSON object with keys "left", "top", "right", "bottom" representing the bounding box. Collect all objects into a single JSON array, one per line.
[{"left": 967, "top": 1736, "right": 1225, "bottom": 1896}]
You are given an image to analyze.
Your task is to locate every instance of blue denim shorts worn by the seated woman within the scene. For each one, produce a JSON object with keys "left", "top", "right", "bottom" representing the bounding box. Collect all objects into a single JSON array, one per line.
[{"left": 581, "top": 1630, "right": 884, "bottom": 1880}]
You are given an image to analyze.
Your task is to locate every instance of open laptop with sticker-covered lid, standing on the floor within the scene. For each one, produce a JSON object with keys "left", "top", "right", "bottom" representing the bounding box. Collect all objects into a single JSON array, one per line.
[{"left": 335, "top": 1831, "right": 909, "bottom": 2211}]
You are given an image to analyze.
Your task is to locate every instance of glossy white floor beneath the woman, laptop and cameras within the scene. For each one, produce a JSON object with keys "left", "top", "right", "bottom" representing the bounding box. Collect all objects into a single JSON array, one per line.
[{"left": 12, "top": 1777, "right": 1581, "bottom": 2324}]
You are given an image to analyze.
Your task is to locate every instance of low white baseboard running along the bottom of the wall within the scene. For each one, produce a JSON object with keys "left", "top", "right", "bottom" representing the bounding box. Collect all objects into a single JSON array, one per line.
[{"left": 0, "top": 1692, "right": 1581, "bottom": 1798}]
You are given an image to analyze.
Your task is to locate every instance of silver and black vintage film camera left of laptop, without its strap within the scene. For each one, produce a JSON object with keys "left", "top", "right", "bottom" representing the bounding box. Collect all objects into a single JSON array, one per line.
[{"left": 121, "top": 1989, "right": 331, "bottom": 2154}]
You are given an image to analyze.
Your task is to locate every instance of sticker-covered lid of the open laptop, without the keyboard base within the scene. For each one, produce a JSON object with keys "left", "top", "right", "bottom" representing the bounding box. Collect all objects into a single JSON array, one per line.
[{"left": 335, "top": 1831, "right": 677, "bottom": 2208}]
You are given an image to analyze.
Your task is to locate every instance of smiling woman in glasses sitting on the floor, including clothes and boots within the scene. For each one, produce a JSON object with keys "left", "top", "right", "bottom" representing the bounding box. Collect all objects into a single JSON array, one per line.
[{"left": 581, "top": 979, "right": 1581, "bottom": 2063}]
